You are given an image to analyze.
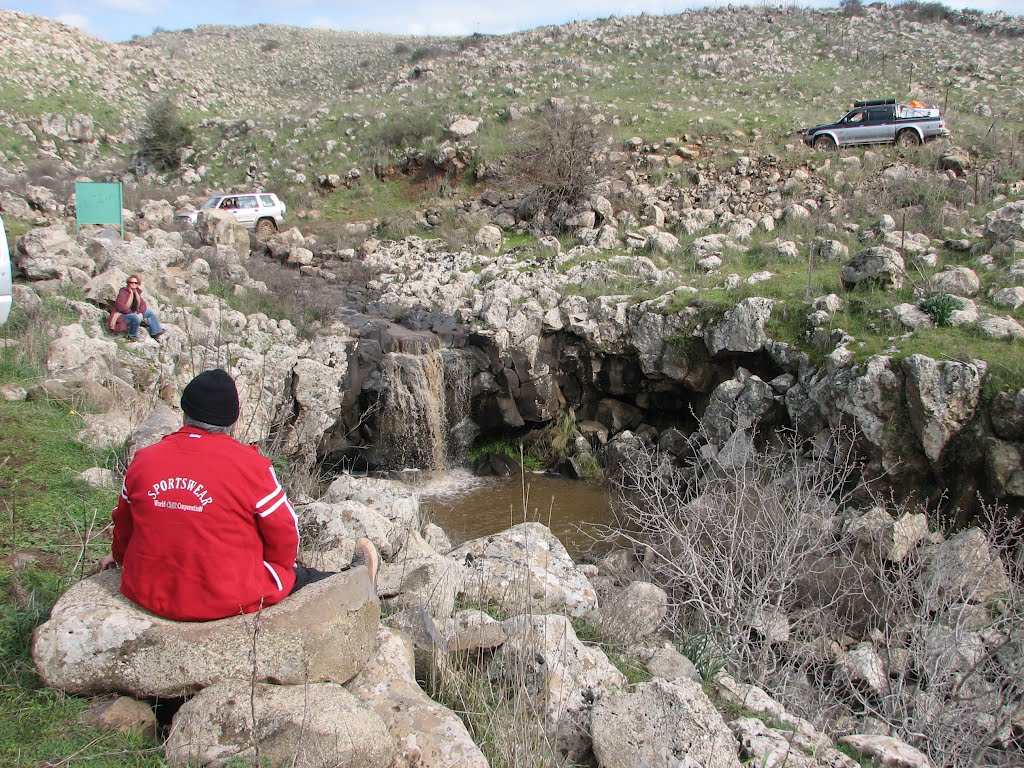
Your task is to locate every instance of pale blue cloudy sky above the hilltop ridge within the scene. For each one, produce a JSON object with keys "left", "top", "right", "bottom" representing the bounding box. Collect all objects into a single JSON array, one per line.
[{"left": 0, "top": 0, "right": 1024, "bottom": 42}]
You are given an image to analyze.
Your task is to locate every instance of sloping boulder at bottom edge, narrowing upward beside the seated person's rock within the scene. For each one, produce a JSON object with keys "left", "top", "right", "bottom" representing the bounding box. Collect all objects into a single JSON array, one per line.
[{"left": 345, "top": 627, "right": 487, "bottom": 768}]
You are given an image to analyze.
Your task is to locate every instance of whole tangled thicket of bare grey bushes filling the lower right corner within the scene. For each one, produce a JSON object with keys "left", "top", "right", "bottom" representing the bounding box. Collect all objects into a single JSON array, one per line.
[{"left": 615, "top": 423, "right": 1024, "bottom": 767}]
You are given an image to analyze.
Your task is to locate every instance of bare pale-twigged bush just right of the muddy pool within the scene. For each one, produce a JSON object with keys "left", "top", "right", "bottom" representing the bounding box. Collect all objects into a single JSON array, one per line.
[{"left": 606, "top": 431, "right": 863, "bottom": 683}]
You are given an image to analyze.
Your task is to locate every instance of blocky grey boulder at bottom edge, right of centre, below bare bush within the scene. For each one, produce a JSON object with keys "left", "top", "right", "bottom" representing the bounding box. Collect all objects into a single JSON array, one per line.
[{"left": 591, "top": 679, "right": 739, "bottom": 768}]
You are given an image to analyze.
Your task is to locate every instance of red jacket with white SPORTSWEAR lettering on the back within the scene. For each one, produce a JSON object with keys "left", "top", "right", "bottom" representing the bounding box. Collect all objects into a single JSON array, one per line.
[{"left": 111, "top": 427, "right": 299, "bottom": 622}]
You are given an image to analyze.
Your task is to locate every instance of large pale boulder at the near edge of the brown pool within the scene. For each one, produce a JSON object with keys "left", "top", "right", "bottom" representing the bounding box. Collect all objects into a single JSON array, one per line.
[{"left": 447, "top": 522, "right": 597, "bottom": 618}]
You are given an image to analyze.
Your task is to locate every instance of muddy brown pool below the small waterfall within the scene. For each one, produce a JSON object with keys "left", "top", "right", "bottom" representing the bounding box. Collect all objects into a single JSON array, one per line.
[{"left": 403, "top": 470, "right": 614, "bottom": 559}]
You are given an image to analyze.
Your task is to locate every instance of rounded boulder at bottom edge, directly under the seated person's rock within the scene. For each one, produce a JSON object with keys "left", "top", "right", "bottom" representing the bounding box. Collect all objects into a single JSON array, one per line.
[{"left": 164, "top": 680, "right": 396, "bottom": 768}]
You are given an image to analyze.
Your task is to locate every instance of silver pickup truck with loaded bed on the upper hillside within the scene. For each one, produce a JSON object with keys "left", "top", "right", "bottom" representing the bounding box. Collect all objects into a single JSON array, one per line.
[{"left": 803, "top": 98, "right": 949, "bottom": 152}]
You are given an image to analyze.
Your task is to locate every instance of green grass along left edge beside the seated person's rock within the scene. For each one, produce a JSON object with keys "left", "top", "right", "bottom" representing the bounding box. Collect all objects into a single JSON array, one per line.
[{"left": 0, "top": 308, "right": 161, "bottom": 768}]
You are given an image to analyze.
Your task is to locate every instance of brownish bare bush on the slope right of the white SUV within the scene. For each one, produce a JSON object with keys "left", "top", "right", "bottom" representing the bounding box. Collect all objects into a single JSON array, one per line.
[{"left": 509, "top": 105, "right": 603, "bottom": 227}]
